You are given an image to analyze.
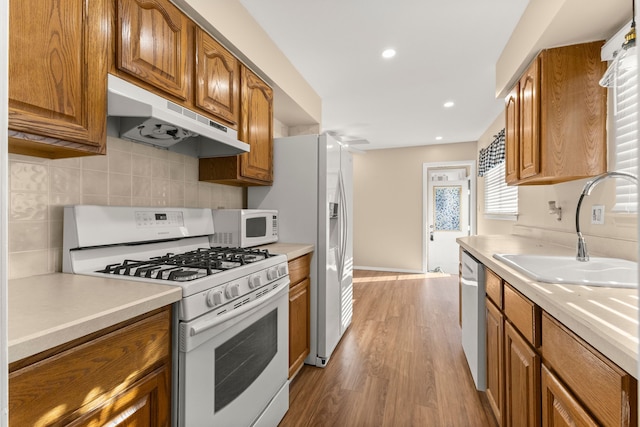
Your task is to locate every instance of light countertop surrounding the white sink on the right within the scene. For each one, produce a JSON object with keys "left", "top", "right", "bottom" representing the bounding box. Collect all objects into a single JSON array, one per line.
[{"left": 457, "top": 235, "right": 638, "bottom": 378}]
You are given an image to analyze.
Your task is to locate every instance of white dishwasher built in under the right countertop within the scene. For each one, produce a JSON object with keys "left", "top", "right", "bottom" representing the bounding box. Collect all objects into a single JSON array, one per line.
[{"left": 460, "top": 250, "right": 487, "bottom": 391}]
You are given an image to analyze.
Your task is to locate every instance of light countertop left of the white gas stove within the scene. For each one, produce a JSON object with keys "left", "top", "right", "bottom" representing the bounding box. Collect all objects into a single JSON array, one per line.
[{"left": 7, "top": 273, "right": 182, "bottom": 363}]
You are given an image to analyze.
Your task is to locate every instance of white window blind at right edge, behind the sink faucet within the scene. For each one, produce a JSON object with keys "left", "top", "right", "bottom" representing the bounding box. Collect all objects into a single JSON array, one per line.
[{"left": 612, "top": 61, "right": 638, "bottom": 212}]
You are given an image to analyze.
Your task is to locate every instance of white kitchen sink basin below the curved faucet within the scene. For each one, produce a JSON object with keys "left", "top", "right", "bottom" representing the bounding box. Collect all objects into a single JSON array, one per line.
[{"left": 493, "top": 254, "right": 638, "bottom": 288}]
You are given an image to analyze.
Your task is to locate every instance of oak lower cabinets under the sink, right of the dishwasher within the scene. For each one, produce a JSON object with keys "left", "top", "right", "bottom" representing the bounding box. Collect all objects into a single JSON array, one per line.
[{"left": 485, "top": 266, "right": 638, "bottom": 427}]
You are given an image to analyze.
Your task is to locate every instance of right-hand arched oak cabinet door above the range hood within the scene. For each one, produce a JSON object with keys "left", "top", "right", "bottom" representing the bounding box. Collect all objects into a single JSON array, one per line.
[{"left": 195, "top": 28, "right": 240, "bottom": 126}]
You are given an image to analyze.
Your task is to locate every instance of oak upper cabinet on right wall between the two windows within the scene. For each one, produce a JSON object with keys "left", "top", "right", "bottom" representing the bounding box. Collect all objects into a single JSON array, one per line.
[{"left": 505, "top": 42, "right": 607, "bottom": 185}]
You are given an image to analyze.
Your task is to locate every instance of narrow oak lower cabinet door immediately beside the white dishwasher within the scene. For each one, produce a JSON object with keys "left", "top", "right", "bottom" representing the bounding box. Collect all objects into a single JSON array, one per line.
[{"left": 485, "top": 298, "right": 504, "bottom": 425}]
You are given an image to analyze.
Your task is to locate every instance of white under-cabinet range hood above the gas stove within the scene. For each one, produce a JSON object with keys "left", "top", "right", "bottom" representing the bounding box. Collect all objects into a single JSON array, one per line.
[{"left": 107, "top": 74, "right": 249, "bottom": 158}]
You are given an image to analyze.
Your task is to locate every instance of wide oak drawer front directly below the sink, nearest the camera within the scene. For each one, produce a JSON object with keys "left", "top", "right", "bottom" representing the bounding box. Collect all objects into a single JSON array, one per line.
[{"left": 542, "top": 313, "right": 638, "bottom": 426}]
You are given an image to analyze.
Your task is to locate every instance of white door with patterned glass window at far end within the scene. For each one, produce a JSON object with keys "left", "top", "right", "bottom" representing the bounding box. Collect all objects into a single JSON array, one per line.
[{"left": 426, "top": 168, "right": 471, "bottom": 274}]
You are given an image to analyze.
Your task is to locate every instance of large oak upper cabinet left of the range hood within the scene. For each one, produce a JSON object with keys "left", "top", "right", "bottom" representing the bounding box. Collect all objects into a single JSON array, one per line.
[{"left": 9, "top": 0, "right": 108, "bottom": 158}]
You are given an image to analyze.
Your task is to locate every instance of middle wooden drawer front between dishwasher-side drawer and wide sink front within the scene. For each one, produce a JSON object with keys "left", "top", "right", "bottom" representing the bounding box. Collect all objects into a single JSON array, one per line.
[{"left": 504, "top": 283, "right": 540, "bottom": 347}]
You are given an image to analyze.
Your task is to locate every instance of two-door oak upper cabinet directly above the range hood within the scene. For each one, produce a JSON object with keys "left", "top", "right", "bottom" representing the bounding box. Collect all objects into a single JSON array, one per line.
[{"left": 111, "top": 0, "right": 245, "bottom": 129}]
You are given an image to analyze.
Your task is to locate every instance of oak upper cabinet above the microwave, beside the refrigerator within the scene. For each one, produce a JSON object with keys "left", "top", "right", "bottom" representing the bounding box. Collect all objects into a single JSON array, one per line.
[{"left": 200, "top": 66, "right": 273, "bottom": 186}]
